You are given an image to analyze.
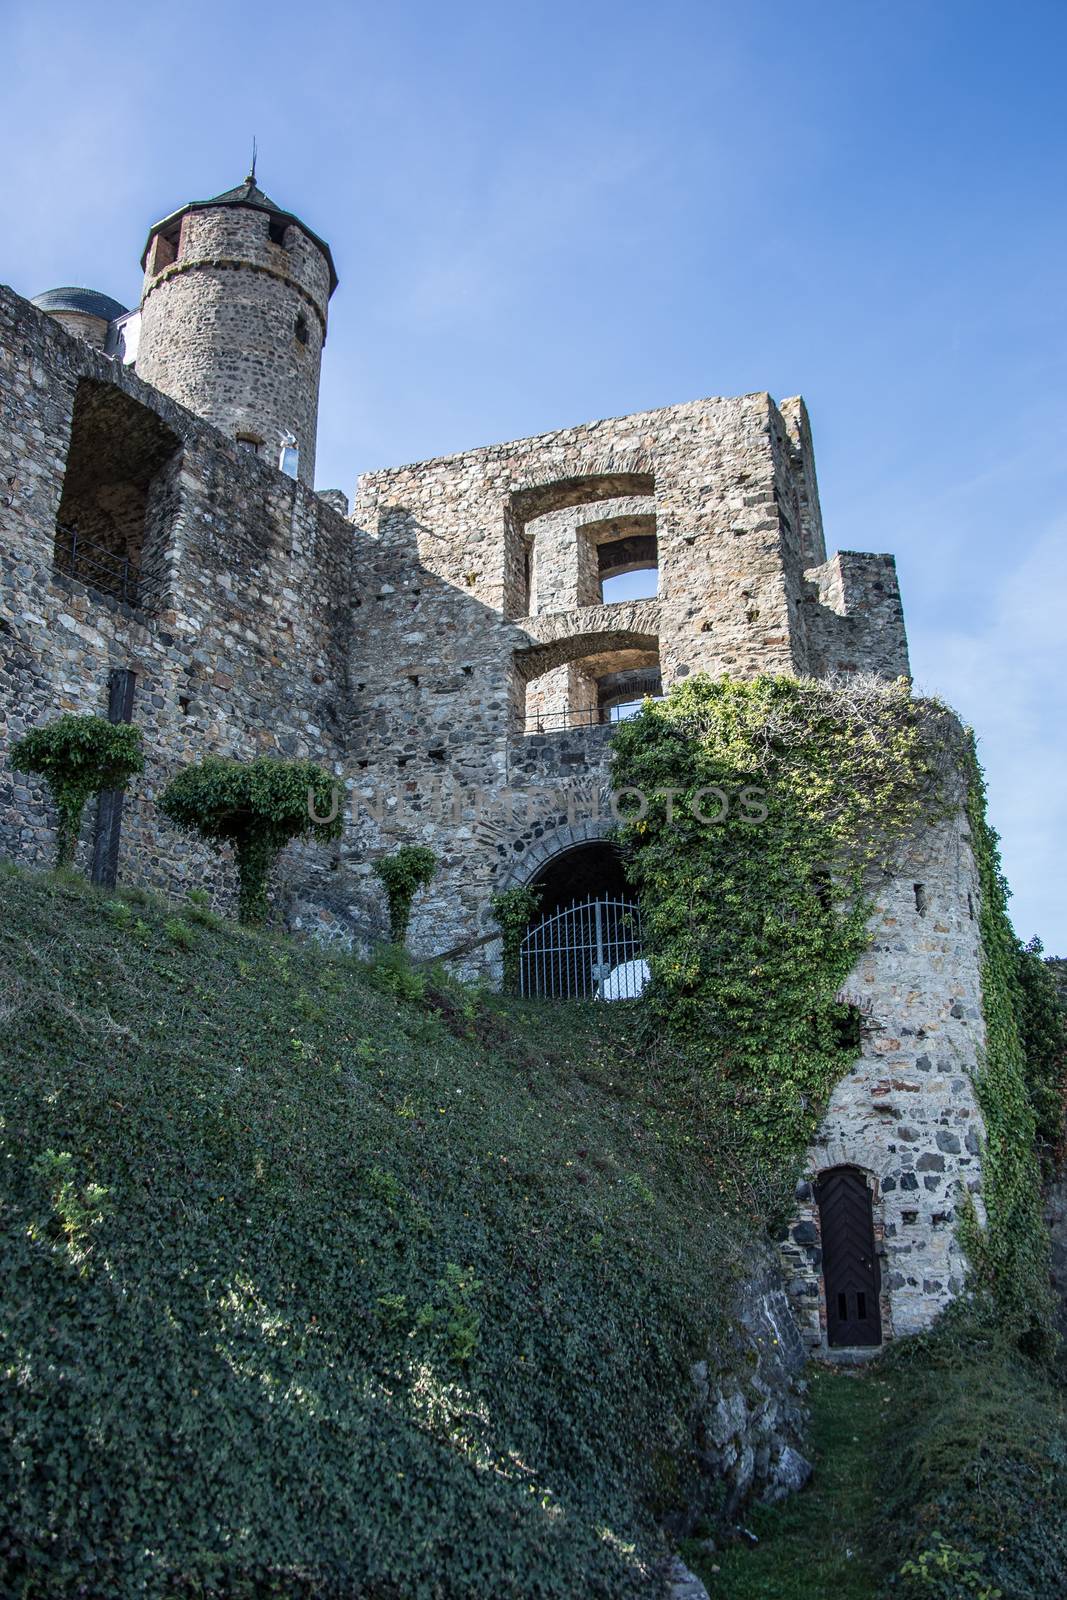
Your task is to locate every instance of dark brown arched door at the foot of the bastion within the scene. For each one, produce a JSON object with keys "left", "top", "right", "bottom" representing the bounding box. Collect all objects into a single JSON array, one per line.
[{"left": 816, "top": 1166, "right": 881, "bottom": 1347}]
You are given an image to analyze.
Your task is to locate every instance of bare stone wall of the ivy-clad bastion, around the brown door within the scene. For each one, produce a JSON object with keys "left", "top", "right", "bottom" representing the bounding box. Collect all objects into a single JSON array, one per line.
[{"left": 782, "top": 818, "right": 985, "bottom": 1350}]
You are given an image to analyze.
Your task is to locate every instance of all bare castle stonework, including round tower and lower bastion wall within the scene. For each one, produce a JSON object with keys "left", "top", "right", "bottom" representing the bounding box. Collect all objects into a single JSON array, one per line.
[{"left": 0, "top": 175, "right": 982, "bottom": 1349}]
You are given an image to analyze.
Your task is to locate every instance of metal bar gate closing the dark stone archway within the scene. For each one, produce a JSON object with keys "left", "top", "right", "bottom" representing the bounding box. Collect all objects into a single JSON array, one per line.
[{"left": 518, "top": 899, "right": 648, "bottom": 1000}]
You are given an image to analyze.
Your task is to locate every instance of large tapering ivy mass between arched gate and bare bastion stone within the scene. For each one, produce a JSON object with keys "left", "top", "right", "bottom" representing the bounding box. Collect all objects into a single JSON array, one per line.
[{"left": 613, "top": 677, "right": 961, "bottom": 1210}]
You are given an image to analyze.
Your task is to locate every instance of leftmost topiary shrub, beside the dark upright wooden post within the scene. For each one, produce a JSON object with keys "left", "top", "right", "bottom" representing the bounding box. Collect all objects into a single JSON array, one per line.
[{"left": 11, "top": 712, "right": 144, "bottom": 867}]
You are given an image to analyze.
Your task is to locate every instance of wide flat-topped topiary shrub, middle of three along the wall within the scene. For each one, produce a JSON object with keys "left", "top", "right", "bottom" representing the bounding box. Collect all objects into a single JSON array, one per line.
[{"left": 158, "top": 755, "right": 342, "bottom": 923}]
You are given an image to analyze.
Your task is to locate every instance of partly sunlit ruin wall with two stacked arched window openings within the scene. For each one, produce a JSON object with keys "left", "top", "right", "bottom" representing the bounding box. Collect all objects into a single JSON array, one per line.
[{"left": 340, "top": 394, "right": 902, "bottom": 970}]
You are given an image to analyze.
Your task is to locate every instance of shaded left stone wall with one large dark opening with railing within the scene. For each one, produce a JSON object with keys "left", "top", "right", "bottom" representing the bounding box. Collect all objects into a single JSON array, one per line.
[{"left": 0, "top": 291, "right": 354, "bottom": 909}]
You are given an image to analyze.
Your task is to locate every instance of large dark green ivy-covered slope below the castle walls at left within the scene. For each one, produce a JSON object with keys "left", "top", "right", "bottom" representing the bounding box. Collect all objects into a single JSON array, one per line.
[{"left": 0, "top": 869, "right": 745, "bottom": 1600}]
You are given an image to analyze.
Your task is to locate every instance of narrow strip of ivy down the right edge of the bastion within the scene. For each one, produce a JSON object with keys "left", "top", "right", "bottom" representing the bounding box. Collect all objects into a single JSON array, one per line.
[{"left": 961, "top": 741, "right": 1062, "bottom": 1355}]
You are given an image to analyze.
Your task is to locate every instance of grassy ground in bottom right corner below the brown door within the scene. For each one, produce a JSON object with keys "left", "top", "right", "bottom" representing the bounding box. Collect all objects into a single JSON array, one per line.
[{"left": 683, "top": 1307, "right": 1067, "bottom": 1600}]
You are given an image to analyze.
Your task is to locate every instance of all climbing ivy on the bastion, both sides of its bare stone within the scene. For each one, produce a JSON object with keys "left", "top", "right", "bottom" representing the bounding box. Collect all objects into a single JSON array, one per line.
[{"left": 613, "top": 677, "right": 1065, "bottom": 1354}]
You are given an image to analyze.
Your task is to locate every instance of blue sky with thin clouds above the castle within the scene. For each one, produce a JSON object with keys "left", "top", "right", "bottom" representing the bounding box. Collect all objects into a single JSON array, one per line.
[{"left": 0, "top": 0, "right": 1067, "bottom": 952}]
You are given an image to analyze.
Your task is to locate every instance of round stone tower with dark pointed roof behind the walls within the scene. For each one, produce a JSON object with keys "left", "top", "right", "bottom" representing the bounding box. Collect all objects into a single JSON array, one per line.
[{"left": 138, "top": 170, "right": 338, "bottom": 485}]
